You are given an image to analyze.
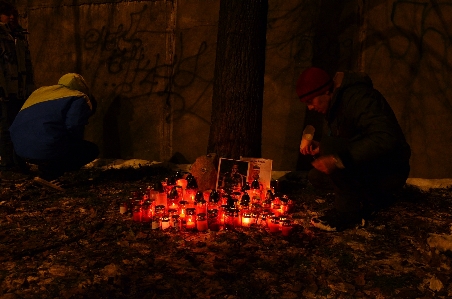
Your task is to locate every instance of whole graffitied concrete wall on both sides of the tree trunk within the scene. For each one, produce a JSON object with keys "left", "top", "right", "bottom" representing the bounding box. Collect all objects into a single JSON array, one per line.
[{"left": 12, "top": 0, "right": 452, "bottom": 178}]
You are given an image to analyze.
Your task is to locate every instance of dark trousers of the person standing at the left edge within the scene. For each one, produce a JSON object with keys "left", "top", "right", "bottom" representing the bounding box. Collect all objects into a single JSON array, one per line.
[{"left": 0, "top": 95, "right": 23, "bottom": 170}]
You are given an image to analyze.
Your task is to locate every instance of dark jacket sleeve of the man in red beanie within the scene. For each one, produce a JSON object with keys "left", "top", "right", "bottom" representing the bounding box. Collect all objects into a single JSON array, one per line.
[{"left": 339, "top": 89, "right": 401, "bottom": 167}]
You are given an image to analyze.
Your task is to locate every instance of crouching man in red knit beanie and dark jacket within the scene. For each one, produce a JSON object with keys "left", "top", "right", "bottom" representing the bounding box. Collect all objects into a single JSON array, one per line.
[{"left": 297, "top": 67, "right": 411, "bottom": 231}]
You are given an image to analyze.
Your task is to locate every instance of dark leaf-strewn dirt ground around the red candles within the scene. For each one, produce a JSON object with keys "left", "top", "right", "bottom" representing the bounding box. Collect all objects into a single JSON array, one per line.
[{"left": 0, "top": 167, "right": 452, "bottom": 299}]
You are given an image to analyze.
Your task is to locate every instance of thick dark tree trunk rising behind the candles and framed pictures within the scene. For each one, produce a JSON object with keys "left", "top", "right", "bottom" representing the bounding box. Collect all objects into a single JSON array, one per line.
[{"left": 208, "top": 0, "right": 268, "bottom": 159}]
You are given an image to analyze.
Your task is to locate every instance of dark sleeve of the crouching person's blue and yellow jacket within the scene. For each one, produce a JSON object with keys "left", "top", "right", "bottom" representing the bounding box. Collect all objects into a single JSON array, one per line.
[{"left": 65, "top": 97, "right": 92, "bottom": 139}]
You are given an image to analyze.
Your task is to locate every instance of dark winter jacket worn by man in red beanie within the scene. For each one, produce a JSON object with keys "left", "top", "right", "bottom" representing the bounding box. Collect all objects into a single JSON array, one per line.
[{"left": 321, "top": 72, "right": 411, "bottom": 175}]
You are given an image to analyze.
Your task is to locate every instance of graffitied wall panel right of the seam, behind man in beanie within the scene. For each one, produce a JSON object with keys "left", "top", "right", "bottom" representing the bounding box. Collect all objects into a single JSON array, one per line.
[{"left": 363, "top": 0, "right": 452, "bottom": 178}]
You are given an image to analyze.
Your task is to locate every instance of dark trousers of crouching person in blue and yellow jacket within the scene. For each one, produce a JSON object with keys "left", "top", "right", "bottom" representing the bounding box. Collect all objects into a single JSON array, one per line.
[{"left": 30, "top": 140, "right": 99, "bottom": 180}]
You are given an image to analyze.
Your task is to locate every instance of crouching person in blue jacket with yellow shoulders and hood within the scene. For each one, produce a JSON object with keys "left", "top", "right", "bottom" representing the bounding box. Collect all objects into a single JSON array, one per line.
[{"left": 10, "top": 73, "right": 99, "bottom": 191}]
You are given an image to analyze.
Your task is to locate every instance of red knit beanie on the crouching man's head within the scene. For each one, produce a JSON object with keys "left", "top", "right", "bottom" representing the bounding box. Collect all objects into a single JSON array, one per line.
[{"left": 297, "top": 67, "right": 333, "bottom": 102}]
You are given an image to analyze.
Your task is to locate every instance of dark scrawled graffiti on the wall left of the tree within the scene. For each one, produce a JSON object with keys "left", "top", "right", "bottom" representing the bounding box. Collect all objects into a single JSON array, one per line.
[{"left": 83, "top": 5, "right": 212, "bottom": 122}]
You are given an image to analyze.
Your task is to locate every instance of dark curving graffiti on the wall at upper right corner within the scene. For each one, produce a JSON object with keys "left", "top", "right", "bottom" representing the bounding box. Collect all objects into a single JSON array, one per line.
[{"left": 366, "top": 1, "right": 452, "bottom": 135}]
